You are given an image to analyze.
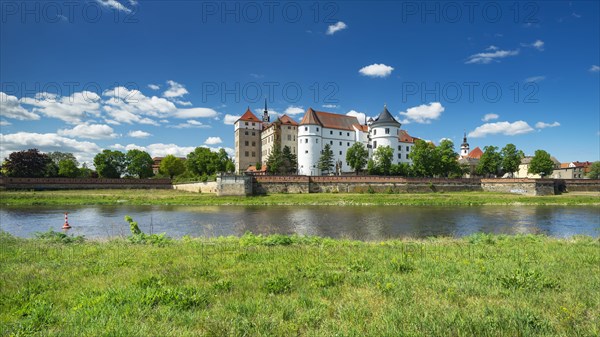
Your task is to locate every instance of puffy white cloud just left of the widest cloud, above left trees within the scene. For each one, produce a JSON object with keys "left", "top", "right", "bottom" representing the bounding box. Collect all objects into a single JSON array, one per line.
[{"left": 21, "top": 91, "right": 101, "bottom": 124}]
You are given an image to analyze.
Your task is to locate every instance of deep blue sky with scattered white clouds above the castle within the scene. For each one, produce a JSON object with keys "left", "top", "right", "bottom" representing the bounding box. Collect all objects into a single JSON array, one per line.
[{"left": 0, "top": 0, "right": 600, "bottom": 162}]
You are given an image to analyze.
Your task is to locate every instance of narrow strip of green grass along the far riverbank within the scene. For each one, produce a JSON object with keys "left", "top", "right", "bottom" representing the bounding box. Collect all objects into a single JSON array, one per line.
[{"left": 0, "top": 190, "right": 600, "bottom": 206}]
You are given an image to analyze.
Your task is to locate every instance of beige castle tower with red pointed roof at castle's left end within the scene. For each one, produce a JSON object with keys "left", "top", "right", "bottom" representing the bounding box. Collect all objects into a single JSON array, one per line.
[{"left": 234, "top": 107, "right": 262, "bottom": 173}]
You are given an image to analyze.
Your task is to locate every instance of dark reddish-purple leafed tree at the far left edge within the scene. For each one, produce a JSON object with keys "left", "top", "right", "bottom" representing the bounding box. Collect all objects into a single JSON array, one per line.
[{"left": 2, "top": 149, "right": 54, "bottom": 178}]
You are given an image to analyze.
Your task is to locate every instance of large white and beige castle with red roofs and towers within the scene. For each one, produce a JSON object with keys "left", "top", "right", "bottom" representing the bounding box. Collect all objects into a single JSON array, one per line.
[{"left": 234, "top": 104, "right": 416, "bottom": 176}]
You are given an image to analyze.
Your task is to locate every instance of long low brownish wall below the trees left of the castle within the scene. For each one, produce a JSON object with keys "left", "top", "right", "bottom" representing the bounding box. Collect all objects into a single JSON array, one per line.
[{"left": 0, "top": 177, "right": 172, "bottom": 190}]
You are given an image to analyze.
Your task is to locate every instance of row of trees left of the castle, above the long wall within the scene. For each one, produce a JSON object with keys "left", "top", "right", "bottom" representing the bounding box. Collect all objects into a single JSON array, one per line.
[{"left": 0, "top": 147, "right": 235, "bottom": 181}]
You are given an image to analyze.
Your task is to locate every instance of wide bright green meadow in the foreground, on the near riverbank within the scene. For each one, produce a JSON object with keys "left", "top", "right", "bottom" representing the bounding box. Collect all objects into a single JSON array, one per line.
[{"left": 0, "top": 233, "right": 600, "bottom": 336}]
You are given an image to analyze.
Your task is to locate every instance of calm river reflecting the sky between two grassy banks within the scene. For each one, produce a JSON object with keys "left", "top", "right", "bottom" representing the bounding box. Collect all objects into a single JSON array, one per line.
[{"left": 0, "top": 206, "right": 600, "bottom": 241}]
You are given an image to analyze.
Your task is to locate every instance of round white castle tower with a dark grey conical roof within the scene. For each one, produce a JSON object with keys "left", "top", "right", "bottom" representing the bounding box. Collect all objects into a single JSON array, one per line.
[{"left": 369, "top": 105, "right": 401, "bottom": 164}]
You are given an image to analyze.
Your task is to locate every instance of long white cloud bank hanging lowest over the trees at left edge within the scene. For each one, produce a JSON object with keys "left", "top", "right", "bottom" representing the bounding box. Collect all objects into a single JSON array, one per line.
[{"left": 0, "top": 132, "right": 101, "bottom": 162}]
